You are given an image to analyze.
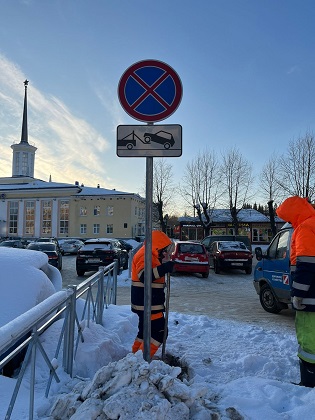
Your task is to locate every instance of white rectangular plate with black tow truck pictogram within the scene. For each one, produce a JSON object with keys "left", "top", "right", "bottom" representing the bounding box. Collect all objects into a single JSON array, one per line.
[{"left": 117, "top": 124, "right": 182, "bottom": 157}]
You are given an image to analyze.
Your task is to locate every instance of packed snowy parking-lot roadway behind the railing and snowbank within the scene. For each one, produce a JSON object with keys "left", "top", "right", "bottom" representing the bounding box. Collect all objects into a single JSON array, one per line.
[{"left": 61, "top": 255, "right": 294, "bottom": 331}]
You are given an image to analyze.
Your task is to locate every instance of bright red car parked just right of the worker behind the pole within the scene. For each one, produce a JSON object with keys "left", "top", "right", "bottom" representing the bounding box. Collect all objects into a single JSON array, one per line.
[{"left": 171, "top": 241, "right": 210, "bottom": 278}]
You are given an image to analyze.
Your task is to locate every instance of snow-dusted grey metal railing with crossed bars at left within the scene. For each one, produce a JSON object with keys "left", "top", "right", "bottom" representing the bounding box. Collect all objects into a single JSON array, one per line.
[{"left": 0, "top": 260, "right": 118, "bottom": 420}]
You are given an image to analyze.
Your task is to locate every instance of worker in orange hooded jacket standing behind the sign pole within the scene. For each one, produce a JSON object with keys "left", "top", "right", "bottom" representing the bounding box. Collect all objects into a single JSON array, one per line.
[{"left": 131, "top": 230, "right": 174, "bottom": 358}]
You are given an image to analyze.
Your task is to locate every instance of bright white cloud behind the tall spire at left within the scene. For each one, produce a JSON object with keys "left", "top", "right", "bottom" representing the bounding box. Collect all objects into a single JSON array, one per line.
[{"left": 0, "top": 54, "right": 115, "bottom": 188}]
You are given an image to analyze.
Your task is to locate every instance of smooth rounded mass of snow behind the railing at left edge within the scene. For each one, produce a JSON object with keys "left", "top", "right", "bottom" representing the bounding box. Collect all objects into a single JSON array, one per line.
[{"left": 0, "top": 247, "right": 62, "bottom": 327}]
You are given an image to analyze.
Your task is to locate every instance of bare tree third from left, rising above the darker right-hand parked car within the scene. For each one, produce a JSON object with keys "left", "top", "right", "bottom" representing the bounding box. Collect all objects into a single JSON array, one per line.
[{"left": 220, "top": 148, "right": 253, "bottom": 235}]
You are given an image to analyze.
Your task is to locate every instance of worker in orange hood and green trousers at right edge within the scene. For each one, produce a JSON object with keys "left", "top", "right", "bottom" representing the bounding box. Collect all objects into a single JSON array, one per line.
[{"left": 277, "top": 196, "right": 315, "bottom": 388}]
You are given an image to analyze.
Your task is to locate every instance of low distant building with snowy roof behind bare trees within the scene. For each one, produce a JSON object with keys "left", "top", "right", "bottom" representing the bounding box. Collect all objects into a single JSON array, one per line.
[{"left": 174, "top": 209, "right": 284, "bottom": 244}]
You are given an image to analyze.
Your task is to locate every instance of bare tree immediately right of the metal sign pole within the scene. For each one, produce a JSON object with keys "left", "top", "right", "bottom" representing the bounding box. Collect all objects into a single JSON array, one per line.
[{"left": 152, "top": 159, "right": 175, "bottom": 232}]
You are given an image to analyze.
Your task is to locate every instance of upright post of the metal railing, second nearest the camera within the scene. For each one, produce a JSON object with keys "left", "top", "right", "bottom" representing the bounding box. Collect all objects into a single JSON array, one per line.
[{"left": 63, "top": 285, "right": 77, "bottom": 377}]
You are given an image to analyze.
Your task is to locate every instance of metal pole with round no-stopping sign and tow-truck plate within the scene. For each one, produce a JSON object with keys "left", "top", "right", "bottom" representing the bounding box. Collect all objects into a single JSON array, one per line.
[{"left": 117, "top": 60, "right": 183, "bottom": 362}]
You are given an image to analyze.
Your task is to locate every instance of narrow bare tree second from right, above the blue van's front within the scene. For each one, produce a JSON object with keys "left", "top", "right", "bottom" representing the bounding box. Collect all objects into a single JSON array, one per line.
[{"left": 259, "top": 156, "right": 281, "bottom": 236}]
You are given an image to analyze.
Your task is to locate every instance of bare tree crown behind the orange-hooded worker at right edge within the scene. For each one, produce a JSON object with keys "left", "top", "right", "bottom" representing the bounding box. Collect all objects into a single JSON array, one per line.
[{"left": 277, "top": 133, "right": 315, "bottom": 200}]
